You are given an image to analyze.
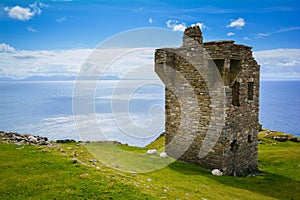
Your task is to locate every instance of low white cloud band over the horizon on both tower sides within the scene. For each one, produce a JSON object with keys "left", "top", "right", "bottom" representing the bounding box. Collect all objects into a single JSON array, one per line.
[{"left": 0, "top": 43, "right": 300, "bottom": 79}]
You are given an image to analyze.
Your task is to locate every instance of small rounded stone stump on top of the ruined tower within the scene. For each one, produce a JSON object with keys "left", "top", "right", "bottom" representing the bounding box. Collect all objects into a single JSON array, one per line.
[{"left": 182, "top": 26, "right": 203, "bottom": 47}]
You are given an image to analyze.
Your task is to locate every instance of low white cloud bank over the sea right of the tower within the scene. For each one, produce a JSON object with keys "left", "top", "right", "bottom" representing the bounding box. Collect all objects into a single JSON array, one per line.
[{"left": 254, "top": 49, "right": 300, "bottom": 79}]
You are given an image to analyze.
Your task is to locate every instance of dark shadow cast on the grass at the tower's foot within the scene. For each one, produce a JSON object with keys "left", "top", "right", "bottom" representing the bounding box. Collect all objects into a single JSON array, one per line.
[{"left": 169, "top": 161, "right": 300, "bottom": 200}]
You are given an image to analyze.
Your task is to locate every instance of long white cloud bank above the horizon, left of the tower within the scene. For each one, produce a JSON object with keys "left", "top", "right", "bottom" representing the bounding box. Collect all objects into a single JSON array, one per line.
[{"left": 0, "top": 44, "right": 158, "bottom": 79}]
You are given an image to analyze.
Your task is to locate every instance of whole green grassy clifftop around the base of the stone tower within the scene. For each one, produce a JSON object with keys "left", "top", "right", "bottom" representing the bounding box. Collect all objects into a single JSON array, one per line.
[{"left": 0, "top": 130, "right": 300, "bottom": 200}]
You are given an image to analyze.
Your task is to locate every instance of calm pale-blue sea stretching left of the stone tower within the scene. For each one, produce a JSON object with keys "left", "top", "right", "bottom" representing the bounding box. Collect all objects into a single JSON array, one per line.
[{"left": 0, "top": 81, "right": 164, "bottom": 146}]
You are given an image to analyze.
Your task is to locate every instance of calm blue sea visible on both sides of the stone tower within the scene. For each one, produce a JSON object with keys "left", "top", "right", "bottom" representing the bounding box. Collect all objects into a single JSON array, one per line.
[{"left": 0, "top": 81, "right": 300, "bottom": 146}]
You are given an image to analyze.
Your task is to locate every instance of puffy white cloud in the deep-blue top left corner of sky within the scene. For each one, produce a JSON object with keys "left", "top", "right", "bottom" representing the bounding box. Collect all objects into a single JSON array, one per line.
[{"left": 4, "top": 0, "right": 48, "bottom": 21}]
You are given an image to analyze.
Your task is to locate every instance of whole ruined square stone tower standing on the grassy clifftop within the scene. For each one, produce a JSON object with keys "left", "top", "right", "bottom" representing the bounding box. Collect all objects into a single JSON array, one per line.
[{"left": 155, "top": 26, "right": 260, "bottom": 175}]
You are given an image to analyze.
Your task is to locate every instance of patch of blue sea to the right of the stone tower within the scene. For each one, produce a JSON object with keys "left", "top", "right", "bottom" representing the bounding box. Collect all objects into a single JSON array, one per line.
[{"left": 260, "top": 81, "right": 300, "bottom": 136}]
